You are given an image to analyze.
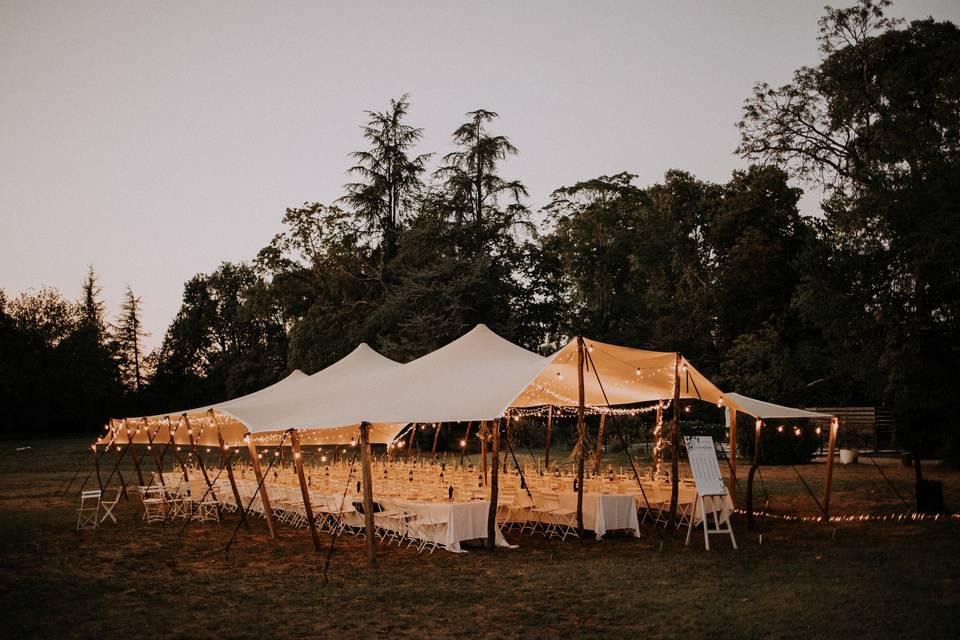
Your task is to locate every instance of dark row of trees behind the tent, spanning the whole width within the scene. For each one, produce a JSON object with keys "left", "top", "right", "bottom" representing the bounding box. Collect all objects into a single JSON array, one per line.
[{"left": 0, "top": 0, "right": 960, "bottom": 464}]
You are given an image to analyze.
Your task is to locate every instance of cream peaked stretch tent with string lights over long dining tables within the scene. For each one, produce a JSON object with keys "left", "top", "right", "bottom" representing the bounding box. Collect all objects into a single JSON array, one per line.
[{"left": 82, "top": 325, "right": 836, "bottom": 562}]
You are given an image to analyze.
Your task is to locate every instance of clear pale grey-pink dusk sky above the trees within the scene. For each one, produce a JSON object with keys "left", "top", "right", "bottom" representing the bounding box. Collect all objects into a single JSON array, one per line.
[{"left": 0, "top": 0, "right": 960, "bottom": 347}]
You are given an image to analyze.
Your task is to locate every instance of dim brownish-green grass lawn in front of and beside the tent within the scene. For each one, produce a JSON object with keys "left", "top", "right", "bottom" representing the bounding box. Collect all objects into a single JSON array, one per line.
[{"left": 0, "top": 439, "right": 960, "bottom": 639}]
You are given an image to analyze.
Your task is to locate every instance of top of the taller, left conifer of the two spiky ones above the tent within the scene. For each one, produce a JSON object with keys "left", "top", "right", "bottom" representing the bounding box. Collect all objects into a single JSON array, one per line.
[{"left": 342, "top": 94, "right": 430, "bottom": 264}]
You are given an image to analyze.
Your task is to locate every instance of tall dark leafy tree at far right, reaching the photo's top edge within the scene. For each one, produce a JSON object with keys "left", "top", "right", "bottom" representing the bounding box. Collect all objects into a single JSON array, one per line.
[{"left": 739, "top": 0, "right": 960, "bottom": 462}]
